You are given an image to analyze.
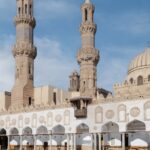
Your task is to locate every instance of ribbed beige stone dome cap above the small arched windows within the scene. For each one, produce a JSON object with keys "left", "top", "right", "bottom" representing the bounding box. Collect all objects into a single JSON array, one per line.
[{"left": 128, "top": 47, "right": 150, "bottom": 75}]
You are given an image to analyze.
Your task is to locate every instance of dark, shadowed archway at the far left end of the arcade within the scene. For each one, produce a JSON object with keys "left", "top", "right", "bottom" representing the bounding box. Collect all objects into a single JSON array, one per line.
[{"left": 0, "top": 129, "right": 8, "bottom": 150}]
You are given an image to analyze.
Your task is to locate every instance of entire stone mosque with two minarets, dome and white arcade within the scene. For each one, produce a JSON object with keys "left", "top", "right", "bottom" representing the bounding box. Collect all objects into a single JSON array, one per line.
[{"left": 0, "top": 0, "right": 150, "bottom": 150}]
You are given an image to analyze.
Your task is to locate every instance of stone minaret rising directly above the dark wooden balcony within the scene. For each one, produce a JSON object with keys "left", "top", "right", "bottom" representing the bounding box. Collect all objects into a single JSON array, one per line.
[{"left": 77, "top": 0, "right": 99, "bottom": 98}]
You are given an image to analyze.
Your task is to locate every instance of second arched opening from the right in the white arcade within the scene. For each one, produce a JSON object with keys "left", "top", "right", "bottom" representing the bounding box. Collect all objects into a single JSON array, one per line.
[{"left": 101, "top": 122, "right": 122, "bottom": 149}]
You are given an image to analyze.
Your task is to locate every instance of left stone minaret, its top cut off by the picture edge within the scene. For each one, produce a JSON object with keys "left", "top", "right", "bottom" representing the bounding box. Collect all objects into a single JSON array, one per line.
[{"left": 11, "top": 0, "right": 36, "bottom": 107}]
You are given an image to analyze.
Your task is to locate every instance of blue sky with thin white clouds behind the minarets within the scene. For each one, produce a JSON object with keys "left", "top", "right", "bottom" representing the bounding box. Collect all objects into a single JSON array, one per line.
[{"left": 0, "top": 0, "right": 150, "bottom": 91}]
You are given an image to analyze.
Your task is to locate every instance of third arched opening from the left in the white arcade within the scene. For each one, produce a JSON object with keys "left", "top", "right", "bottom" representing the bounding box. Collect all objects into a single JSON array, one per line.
[{"left": 22, "top": 127, "right": 34, "bottom": 150}]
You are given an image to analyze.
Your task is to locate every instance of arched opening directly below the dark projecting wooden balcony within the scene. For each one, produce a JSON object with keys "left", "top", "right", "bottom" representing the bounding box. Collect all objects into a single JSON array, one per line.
[{"left": 75, "top": 123, "right": 92, "bottom": 150}]
